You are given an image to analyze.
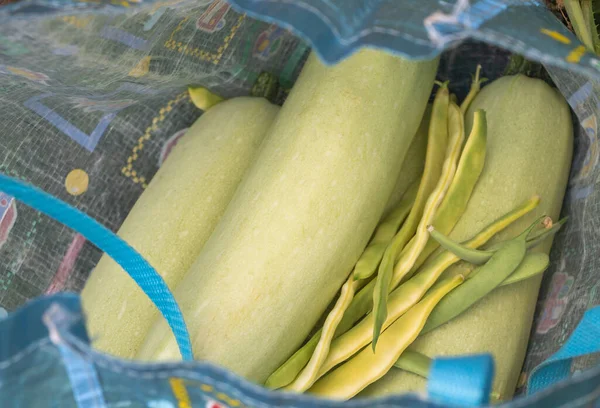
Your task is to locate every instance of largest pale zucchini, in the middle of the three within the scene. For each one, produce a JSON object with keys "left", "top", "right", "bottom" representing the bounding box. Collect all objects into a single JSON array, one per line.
[{"left": 138, "top": 50, "right": 438, "bottom": 383}]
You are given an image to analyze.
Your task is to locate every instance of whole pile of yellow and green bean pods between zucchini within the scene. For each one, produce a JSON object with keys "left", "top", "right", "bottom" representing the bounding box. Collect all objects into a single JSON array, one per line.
[{"left": 265, "top": 67, "right": 566, "bottom": 399}]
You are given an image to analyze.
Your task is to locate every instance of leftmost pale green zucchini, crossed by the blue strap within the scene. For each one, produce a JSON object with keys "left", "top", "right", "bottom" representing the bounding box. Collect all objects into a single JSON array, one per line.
[{"left": 82, "top": 97, "right": 279, "bottom": 358}]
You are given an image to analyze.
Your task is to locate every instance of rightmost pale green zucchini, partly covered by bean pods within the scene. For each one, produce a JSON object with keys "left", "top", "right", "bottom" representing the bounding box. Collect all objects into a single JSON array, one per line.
[{"left": 360, "top": 75, "right": 573, "bottom": 399}]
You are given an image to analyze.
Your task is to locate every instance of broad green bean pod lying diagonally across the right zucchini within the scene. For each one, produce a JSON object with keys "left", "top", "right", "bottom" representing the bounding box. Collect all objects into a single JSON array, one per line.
[{"left": 422, "top": 224, "right": 535, "bottom": 334}]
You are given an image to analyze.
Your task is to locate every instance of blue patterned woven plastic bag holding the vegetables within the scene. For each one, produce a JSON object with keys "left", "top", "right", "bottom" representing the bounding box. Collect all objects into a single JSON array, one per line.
[{"left": 0, "top": 0, "right": 600, "bottom": 408}]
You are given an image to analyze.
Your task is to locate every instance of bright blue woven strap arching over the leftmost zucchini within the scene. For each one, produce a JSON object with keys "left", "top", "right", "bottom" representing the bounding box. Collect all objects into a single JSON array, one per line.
[{"left": 0, "top": 173, "right": 193, "bottom": 360}]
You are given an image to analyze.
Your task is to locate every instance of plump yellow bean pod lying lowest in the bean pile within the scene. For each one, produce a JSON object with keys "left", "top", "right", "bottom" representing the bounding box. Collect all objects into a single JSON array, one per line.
[{"left": 308, "top": 275, "right": 464, "bottom": 399}]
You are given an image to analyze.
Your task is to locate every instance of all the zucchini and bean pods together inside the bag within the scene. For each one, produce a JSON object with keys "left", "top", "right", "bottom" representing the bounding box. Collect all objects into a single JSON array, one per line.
[{"left": 78, "top": 50, "right": 573, "bottom": 399}]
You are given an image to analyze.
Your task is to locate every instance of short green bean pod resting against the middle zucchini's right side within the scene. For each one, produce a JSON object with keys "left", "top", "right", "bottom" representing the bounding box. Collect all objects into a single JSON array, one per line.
[{"left": 354, "top": 182, "right": 419, "bottom": 280}]
